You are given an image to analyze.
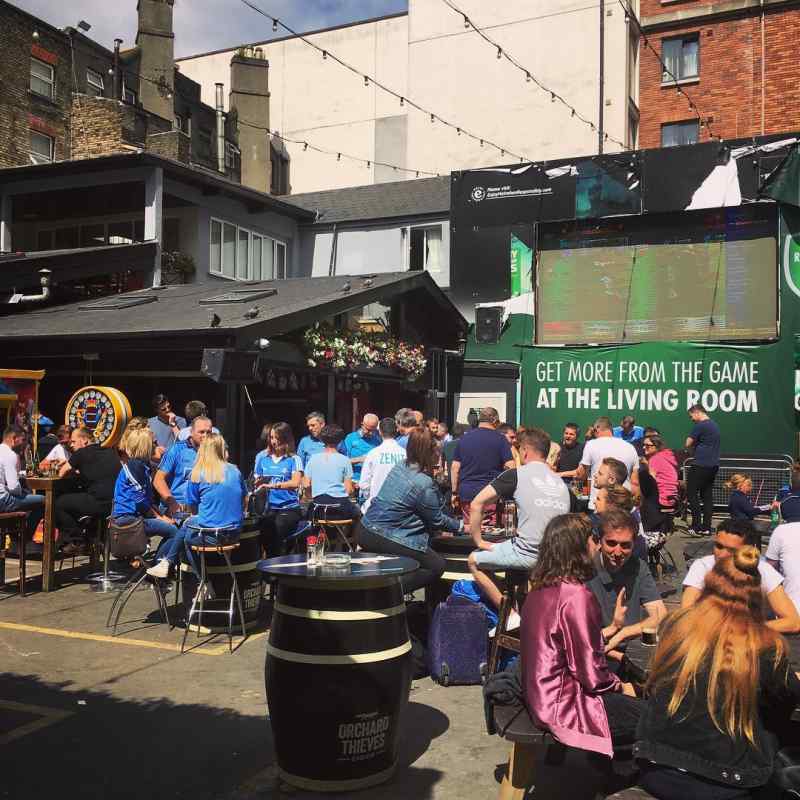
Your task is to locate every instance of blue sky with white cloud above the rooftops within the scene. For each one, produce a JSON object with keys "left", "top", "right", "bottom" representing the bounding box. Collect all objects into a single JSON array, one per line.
[{"left": 11, "top": 0, "right": 408, "bottom": 58}]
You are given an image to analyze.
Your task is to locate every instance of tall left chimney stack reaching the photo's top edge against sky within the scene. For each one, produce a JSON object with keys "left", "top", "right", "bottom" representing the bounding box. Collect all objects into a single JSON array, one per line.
[{"left": 136, "top": 0, "right": 175, "bottom": 122}]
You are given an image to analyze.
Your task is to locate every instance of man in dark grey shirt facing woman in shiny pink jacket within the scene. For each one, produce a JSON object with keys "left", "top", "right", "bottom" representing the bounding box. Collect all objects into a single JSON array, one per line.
[{"left": 586, "top": 509, "right": 667, "bottom": 669}]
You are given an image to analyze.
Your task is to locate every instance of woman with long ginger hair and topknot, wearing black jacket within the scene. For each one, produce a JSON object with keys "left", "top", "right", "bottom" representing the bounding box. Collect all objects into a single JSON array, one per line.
[{"left": 635, "top": 545, "right": 800, "bottom": 800}]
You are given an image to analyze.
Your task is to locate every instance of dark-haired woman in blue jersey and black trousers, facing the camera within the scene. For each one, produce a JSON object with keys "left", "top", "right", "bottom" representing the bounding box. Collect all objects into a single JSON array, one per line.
[{"left": 253, "top": 422, "right": 303, "bottom": 556}]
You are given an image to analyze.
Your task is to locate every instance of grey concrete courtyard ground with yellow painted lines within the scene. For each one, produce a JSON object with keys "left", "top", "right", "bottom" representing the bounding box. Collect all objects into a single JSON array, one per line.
[{"left": 0, "top": 535, "right": 686, "bottom": 800}]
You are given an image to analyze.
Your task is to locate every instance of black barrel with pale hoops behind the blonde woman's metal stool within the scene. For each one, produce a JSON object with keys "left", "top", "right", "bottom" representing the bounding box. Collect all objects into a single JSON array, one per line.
[{"left": 182, "top": 517, "right": 261, "bottom": 632}]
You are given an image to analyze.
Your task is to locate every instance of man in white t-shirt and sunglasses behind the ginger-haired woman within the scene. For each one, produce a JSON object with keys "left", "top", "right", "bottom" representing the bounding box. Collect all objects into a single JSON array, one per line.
[{"left": 681, "top": 519, "right": 800, "bottom": 633}]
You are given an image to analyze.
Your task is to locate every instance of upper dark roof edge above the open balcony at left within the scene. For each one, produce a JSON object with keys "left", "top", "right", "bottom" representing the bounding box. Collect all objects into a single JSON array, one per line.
[{"left": 0, "top": 150, "right": 314, "bottom": 220}]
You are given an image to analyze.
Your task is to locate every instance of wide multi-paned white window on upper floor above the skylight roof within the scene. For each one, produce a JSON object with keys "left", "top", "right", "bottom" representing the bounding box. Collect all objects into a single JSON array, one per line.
[{"left": 209, "top": 219, "right": 286, "bottom": 281}]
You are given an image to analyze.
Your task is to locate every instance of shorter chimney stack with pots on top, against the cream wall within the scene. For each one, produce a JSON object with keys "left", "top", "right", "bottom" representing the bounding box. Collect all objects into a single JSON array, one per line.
[{"left": 228, "top": 47, "right": 272, "bottom": 192}]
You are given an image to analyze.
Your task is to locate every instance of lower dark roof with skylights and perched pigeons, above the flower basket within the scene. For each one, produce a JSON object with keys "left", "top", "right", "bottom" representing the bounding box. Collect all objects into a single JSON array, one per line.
[{"left": 0, "top": 272, "right": 466, "bottom": 349}]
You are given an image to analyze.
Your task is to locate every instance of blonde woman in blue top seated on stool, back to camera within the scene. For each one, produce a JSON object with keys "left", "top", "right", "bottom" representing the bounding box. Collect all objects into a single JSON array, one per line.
[{"left": 183, "top": 433, "right": 247, "bottom": 572}]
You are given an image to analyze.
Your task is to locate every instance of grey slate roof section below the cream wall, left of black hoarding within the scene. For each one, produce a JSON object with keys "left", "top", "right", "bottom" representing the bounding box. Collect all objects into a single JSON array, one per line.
[{"left": 283, "top": 175, "right": 450, "bottom": 225}]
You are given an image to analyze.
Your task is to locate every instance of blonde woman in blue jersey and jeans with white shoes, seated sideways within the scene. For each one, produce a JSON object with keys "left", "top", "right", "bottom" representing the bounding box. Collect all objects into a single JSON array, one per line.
[{"left": 111, "top": 428, "right": 184, "bottom": 578}]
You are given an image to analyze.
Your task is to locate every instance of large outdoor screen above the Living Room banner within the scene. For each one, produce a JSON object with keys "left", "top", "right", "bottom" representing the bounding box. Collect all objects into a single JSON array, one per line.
[{"left": 536, "top": 208, "right": 778, "bottom": 344}]
